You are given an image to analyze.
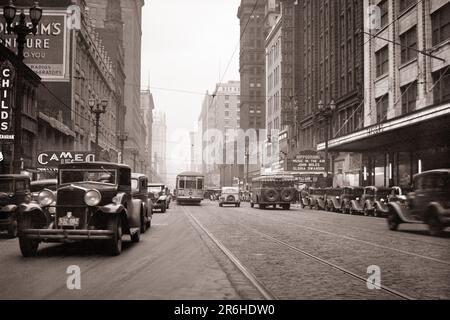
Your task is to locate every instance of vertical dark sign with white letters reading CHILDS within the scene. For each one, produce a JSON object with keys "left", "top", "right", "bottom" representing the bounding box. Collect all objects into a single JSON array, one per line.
[{"left": 0, "top": 63, "right": 14, "bottom": 140}]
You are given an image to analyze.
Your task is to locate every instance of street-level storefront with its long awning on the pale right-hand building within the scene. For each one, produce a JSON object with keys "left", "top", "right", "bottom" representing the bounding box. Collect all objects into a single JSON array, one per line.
[{"left": 318, "top": 103, "right": 450, "bottom": 187}]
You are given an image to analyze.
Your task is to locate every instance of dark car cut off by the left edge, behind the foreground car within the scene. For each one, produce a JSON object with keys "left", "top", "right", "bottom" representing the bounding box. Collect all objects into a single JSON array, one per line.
[{"left": 0, "top": 174, "right": 31, "bottom": 238}]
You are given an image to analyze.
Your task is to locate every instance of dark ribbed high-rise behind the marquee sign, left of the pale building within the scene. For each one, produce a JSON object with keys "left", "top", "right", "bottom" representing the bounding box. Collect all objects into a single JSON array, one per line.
[{"left": 280, "top": 0, "right": 366, "bottom": 186}]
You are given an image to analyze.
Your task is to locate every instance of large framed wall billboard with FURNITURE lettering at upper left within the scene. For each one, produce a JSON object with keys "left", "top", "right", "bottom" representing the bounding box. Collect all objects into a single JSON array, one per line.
[{"left": 0, "top": 10, "right": 68, "bottom": 81}]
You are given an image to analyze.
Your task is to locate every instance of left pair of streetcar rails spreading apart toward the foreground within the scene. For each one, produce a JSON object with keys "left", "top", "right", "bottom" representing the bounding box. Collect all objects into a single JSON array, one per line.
[{"left": 183, "top": 208, "right": 415, "bottom": 300}]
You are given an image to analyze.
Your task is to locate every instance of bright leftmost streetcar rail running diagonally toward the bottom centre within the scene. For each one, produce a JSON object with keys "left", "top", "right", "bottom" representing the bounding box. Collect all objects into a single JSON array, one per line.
[{"left": 181, "top": 206, "right": 277, "bottom": 300}]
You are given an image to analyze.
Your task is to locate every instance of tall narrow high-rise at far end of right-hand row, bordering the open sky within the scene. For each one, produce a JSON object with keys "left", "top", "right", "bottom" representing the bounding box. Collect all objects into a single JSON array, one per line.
[{"left": 237, "top": 0, "right": 266, "bottom": 178}]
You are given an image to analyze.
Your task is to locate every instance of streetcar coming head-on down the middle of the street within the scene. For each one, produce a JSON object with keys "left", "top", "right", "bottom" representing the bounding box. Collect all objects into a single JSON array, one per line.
[{"left": 176, "top": 172, "right": 205, "bottom": 205}]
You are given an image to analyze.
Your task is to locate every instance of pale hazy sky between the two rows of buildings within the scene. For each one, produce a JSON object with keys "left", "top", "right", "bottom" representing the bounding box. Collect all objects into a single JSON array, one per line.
[{"left": 142, "top": 0, "right": 240, "bottom": 182}]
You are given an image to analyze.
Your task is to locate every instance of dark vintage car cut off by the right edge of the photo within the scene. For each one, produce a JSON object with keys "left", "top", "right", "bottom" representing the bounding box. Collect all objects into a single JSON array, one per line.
[{"left": 387, "top": 169, "right": 450, "bottom": 236}]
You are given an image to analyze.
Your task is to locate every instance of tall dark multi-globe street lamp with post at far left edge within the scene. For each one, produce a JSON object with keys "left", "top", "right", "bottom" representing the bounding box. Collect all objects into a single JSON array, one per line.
[{"left": 3, "top": 0, "right": 42, "bottom": 173}]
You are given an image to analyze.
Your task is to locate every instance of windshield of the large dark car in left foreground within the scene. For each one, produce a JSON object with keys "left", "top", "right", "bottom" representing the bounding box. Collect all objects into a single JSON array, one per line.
[{"left": 60, "top": 169, "right": 117, "bottom": 184}]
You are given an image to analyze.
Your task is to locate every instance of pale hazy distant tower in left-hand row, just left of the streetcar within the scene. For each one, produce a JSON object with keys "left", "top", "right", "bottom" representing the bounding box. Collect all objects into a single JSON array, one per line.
[{"left": 151, "top": 110, "right": 167, "bottom": 183}]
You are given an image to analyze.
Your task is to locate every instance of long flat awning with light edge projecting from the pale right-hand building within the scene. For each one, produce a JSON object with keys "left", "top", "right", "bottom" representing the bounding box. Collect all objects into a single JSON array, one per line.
[{"left": 317, "top": 103, "right": 450, "bottom": 152}]
